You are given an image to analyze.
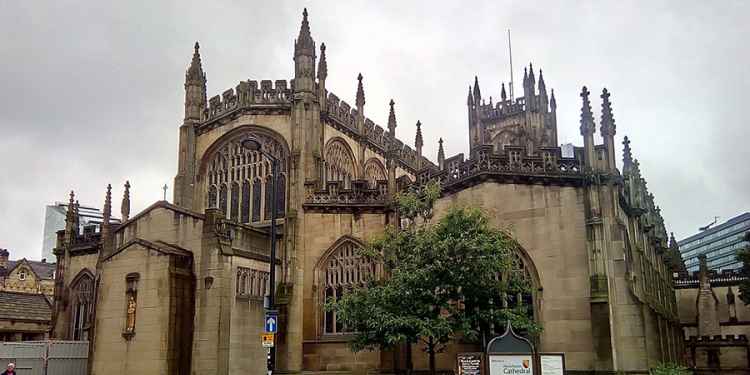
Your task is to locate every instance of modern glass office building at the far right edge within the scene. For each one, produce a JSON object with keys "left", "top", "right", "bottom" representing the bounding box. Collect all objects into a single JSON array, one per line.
[{"left": 677, "top": 212, "right": 750, "bottom": 273}]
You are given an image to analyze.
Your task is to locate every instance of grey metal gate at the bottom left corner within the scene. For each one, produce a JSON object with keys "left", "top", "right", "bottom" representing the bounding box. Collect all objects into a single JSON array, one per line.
[{"left": 0, "top": 341, "right": 89, "bottom": 375}]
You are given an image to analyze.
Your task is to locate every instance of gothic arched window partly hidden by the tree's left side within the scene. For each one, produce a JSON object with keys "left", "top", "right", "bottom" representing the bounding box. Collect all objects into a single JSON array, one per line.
[{"left": 319, "top": 239, "right": 380, "bottom": 334}]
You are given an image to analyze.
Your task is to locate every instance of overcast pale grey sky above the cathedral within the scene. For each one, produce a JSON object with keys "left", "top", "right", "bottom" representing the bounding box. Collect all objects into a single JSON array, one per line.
[{"left": 0, "top": 0, "right": 750, "bottom": 259}]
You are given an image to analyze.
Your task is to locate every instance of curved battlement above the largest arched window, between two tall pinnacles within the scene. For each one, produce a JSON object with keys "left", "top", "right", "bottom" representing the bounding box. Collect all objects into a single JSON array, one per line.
[{"left": 202, "top": 79, "right": 294, "bottom": 121}]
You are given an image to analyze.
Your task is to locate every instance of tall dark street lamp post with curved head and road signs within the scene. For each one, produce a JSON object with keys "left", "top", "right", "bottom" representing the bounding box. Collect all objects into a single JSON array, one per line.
[{"left": 240, "top": 137, "right": 279, "bottom": 375}]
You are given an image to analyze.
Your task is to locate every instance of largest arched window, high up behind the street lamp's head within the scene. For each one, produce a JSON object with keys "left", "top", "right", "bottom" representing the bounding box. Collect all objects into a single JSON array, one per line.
[{"left": 201, "top": 129, "right": 288, "bottom": 223}]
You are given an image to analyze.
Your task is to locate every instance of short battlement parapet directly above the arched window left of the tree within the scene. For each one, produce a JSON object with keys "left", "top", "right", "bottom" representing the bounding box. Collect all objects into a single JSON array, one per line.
[{"left": 304, "top": 180, "right": 388, "bottom": 211}]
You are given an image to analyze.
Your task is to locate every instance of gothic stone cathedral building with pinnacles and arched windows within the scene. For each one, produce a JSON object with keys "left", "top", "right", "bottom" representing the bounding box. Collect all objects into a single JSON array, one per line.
[{"left": 53, "top": 10, "right": 683, "bottom": 375}]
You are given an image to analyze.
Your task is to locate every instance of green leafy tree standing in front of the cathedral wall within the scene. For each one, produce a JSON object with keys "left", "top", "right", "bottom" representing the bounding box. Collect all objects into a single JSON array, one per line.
[{"left": 327, "top": 183, "right": 539, "bottom": 374}]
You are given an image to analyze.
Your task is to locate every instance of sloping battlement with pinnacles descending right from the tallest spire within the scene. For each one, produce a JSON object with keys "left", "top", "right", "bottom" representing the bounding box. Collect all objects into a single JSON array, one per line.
[{"left": 326, "top": 93, "right": 436, "bottom": 172}]
